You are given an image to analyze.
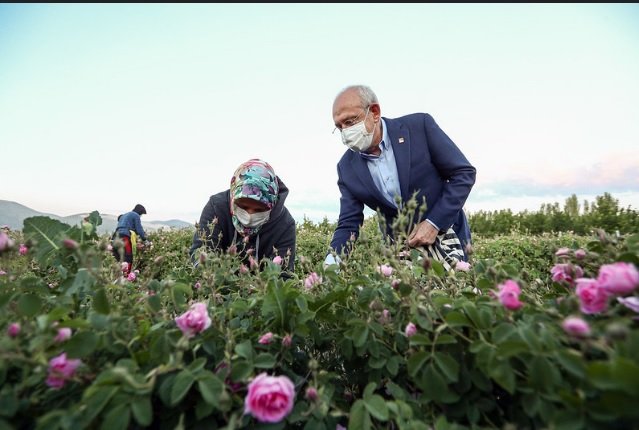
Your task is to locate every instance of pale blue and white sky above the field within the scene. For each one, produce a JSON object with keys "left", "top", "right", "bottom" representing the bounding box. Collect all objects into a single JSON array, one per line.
[{"left": 0, "top": 3, "right": 639, "bottom": 223}]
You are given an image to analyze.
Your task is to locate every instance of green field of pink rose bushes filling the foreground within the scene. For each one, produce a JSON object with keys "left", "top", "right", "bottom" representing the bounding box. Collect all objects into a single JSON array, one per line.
[{"left": 0, "top": 212, "right": 639, "bottom": 430}]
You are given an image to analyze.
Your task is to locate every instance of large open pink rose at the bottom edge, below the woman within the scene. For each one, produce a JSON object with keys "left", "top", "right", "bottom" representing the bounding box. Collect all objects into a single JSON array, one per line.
[{"left": 244, "top": 373, "right": 295, "bottom": 423}]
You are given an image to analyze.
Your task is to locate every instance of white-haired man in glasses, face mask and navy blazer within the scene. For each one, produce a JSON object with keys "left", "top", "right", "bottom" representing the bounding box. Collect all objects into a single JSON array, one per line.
[{"left": 325, "top": 85, "right": 476, "bottom": 265}]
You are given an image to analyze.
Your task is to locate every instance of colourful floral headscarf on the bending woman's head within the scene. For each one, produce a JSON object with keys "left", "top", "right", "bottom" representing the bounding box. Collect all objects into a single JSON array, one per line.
[{"left": 230, "top": 158, "right": 280, "bottom": 236}]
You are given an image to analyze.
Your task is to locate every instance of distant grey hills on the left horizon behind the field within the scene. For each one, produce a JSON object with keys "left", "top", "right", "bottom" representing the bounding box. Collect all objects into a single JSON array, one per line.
[{"left": 0, "top": 200, "right": 194, "bottom": 234}]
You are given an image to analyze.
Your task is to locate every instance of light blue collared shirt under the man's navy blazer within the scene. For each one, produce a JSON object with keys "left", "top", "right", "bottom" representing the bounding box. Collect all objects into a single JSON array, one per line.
[{"left": 360, "top": 119, "right": 402, "bottom": 209}]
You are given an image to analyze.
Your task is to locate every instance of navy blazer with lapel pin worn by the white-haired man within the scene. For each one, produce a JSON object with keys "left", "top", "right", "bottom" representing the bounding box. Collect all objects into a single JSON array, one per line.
[{"left": 331, "top": 113, "right": 476, "bottom": 253}]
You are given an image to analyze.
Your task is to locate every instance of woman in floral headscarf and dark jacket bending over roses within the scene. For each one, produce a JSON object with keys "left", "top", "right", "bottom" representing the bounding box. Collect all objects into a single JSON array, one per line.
[{"left": 189, "top": 159, "right": 296, "bottom": 272}]
